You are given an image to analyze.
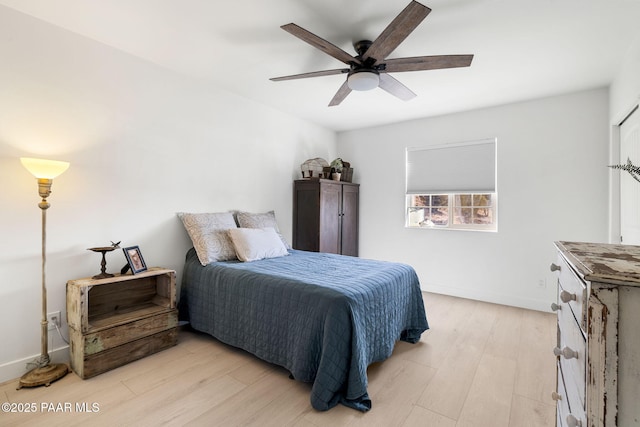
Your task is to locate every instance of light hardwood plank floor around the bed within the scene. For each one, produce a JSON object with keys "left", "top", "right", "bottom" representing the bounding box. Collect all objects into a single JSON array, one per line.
[{"left": 0, "top": 293, "right": 556, "bottom": 427}]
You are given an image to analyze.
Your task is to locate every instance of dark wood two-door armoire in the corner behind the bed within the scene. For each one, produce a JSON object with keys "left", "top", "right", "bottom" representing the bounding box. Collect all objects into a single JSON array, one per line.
[{"left": 293, "top": 179, "right": 360, "bottom": 256}]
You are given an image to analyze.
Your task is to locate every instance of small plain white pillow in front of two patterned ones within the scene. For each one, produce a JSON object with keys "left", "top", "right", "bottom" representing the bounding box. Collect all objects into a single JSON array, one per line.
[{"left": 227, "top": 227, "right": 289, "bottom": 262}]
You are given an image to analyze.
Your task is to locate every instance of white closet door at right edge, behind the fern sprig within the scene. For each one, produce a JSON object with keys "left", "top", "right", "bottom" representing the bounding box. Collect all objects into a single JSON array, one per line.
[{"left": 620, "top": 109, "right": 640, "bottom": 245}]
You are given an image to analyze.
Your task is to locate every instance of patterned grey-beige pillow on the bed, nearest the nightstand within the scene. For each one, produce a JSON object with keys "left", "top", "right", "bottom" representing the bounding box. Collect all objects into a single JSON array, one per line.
[{"left": 178, "top": 212, "right": 237, "bottom": 265}]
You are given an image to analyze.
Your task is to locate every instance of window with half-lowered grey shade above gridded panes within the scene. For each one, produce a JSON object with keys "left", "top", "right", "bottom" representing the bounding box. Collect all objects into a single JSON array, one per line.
[{"left": 405, "top": 139, "right": 497, "bottom": 231}]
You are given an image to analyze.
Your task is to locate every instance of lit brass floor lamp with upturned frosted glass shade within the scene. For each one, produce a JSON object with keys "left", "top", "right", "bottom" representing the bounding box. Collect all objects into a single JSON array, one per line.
[{"left": 18, "top": 157, "right": 69, "bottom": 389}]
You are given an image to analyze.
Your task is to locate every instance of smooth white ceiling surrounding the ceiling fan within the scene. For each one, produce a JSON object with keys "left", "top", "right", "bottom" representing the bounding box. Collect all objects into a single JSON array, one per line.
[{"left": 0, "top": 0, "right": 640, "bottom": 131}]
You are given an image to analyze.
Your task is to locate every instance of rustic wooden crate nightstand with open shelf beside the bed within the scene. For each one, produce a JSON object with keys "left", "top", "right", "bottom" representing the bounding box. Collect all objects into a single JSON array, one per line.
[{"left": 67, "top": 268, "right": 178, "bottom": 378}]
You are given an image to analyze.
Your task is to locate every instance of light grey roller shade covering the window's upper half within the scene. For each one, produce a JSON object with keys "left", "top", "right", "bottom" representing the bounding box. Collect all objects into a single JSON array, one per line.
[{"left": 406, "top": 138, "right": 496, "bottom": 194}]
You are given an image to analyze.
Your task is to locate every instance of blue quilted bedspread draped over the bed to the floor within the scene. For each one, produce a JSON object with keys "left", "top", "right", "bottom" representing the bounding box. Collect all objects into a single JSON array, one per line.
[{"left": 180, "top": 249, "right": 429, "bottom": 411}]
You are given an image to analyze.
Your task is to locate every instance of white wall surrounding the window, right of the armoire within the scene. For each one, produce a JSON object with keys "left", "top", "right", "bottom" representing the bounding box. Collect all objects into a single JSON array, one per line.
[{"left": 338, "top": 89, "right": 609, "bottom": 310}]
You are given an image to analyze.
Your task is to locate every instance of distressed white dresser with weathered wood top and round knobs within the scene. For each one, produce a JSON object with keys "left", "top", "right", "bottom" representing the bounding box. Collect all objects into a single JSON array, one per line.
[{"left": 551, "top": 242, "right": 640, "bottom": 427}]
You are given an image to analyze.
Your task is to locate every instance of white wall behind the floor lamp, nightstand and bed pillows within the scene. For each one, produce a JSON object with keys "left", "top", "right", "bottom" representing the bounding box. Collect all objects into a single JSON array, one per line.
[{"left": 0, "top": 6, "right": 336, "bottom": 382}]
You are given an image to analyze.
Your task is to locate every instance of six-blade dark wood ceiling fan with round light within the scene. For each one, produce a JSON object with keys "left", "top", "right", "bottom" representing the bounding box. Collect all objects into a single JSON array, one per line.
[{"left": 270, "top": 1, "right": 473, "bottom": 106}]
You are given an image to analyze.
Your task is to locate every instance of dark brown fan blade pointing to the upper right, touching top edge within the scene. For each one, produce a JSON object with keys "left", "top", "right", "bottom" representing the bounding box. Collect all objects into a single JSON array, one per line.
[{"left": 363, "top": 1, "right": 431, "bottom": 64}]
